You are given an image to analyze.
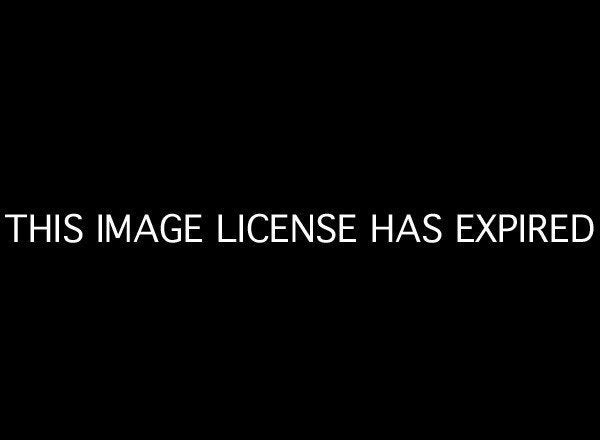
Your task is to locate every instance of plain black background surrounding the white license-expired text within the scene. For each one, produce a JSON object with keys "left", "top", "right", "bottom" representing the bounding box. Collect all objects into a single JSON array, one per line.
[{"left": 1, "top": 5, "right": 598, "bottom": 433}]
